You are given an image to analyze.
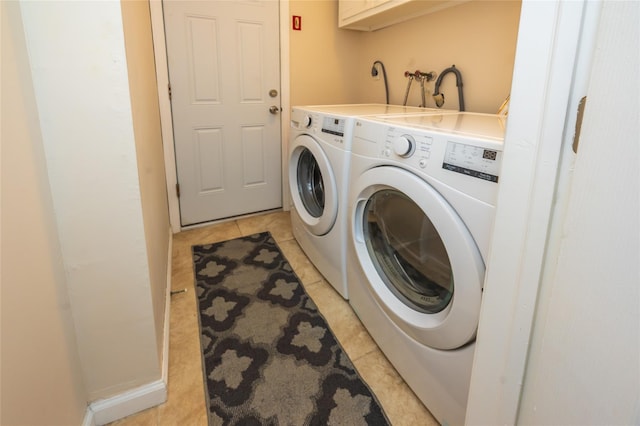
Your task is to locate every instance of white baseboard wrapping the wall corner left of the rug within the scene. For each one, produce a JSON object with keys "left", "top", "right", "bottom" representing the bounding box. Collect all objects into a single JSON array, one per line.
[{"left": 82, "top": 230, "right": 173, "bottom": 426}]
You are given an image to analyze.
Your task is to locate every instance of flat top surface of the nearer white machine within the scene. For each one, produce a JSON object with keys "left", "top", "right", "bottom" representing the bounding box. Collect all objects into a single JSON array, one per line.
[{"left": 368, "top": 112, "right": 506, "bottom": 141}]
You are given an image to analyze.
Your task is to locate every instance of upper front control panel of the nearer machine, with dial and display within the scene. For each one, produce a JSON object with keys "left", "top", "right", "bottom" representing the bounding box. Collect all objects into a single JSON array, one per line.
[{"left": 351, "top": 115, "right": 504, "bottom": 208}]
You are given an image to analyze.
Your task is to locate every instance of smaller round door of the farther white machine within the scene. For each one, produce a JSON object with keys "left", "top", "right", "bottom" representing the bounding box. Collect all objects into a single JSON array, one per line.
[{"left": 289, "top": 135, "right": 338, "bottom": 236}]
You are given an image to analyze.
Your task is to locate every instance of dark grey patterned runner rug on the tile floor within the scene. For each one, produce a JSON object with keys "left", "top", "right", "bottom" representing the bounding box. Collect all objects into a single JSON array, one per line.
[{"left": 193, "top": 232, "right": 389, "bottom": 426}]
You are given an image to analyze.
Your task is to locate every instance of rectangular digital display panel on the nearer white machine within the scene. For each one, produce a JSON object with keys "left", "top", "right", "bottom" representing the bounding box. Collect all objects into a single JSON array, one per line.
[{"left": 442, "top": 141, "right": 501, "bottom": 182}]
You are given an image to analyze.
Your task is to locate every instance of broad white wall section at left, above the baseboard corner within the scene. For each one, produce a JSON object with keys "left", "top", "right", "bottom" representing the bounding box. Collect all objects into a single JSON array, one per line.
[{"left": 21, "top": 1, "right": 162, "bottom": 400}]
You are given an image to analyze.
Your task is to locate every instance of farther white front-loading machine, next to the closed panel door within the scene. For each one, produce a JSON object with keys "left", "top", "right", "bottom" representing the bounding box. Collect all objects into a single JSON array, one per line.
[{"left": 288, "top": 104, "right": 440, "bottom": 299}]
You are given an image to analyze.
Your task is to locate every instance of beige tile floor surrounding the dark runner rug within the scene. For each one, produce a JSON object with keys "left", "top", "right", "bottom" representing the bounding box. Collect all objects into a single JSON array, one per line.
[{"left": 111, "top": 212, "right": 438, "bottom": 426}]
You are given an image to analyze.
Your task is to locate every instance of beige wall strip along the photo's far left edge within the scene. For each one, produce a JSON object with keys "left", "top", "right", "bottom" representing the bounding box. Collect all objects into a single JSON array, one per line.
[{"left": 0, "top": 2, "right": 88, "bottom": 425}]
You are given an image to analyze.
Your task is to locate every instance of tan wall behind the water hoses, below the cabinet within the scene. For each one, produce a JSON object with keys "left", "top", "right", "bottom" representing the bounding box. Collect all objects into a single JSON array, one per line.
[{"left": 358, "top": 0, "right": 521, "bottom": 113}]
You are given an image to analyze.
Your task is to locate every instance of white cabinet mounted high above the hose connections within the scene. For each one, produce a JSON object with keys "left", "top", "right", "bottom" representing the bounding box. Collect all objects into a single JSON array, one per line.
[{"left": 338, "top": 0, "right": 470, "bottom": 31}]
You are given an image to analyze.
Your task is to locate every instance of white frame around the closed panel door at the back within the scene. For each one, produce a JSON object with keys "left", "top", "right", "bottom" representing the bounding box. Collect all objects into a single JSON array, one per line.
[{"left": 149, "top": 0, "right": 291, "bottom": 234}]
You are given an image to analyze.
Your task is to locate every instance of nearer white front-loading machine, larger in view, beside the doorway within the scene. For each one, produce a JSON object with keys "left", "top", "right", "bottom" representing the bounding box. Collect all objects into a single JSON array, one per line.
[{"left": 347, "top": 113, "right": 504, "bottom": 425}]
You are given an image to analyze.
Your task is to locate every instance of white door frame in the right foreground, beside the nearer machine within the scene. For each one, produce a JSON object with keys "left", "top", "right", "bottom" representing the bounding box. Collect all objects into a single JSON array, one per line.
[{"left": 465, "top": 0, "right": 602, "bottom": 424}]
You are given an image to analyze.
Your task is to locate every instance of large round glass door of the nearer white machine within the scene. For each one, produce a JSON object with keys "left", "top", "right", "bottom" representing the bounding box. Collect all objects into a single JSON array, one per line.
[{"left": 351, "top": 166, "right": 485, "bottom": 350}]
